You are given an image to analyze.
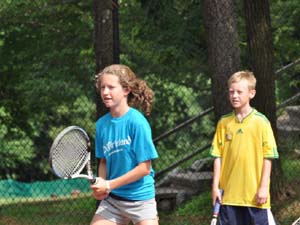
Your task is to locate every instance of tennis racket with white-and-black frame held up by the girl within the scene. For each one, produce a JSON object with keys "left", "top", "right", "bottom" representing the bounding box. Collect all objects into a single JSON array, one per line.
[{"left": 49, "top": 126, "right": 96, "bottom": 184}]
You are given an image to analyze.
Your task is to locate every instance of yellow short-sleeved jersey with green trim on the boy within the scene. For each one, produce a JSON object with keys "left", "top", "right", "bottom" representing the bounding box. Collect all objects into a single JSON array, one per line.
[{"left": 210, "top": 109, "right": 279, "bottom": 208}]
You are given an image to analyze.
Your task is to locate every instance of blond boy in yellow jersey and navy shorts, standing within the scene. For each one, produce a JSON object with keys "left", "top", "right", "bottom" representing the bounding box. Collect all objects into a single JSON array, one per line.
[{"left": 210, "top": 71, "right": 278, "bottom": 225}]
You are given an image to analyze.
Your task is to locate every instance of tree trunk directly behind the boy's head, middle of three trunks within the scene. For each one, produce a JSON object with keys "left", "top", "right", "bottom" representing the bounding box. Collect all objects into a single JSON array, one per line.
[{"left": 203, "top": 0, "right": 240, "bottom": 122}]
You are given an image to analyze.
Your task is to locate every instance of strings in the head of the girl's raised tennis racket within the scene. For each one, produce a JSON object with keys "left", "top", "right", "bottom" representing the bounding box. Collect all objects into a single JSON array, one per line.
[{"left": 52, "top": 130, "right": 89, "bottom": 178}]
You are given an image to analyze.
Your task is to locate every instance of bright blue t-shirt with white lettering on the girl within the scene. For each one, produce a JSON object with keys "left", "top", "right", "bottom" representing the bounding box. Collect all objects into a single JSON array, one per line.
[{"left": 95, "top": 108, "right": 158, "bottom": 200}]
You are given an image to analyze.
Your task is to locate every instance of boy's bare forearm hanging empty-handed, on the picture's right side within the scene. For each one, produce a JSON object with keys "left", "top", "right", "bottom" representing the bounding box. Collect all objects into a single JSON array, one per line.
[{"left": 256, "top": 158, "right": 272, "bottom": 205}]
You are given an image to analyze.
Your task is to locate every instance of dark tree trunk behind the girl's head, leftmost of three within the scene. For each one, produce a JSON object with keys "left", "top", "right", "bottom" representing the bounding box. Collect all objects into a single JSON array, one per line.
[{"left": 93, "top": 0, "right": 119, "bottom": 118}]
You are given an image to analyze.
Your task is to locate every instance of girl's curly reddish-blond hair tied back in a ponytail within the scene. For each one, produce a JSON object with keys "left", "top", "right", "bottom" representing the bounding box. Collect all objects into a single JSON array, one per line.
[{"left": 96, "top": 64, "right": 154, "bottom": 116}]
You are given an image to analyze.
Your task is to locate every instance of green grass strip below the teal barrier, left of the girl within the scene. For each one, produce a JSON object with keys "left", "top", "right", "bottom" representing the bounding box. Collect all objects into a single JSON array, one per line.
[{"left": 0, "top": 196, "right": 95, "bottom": 225}]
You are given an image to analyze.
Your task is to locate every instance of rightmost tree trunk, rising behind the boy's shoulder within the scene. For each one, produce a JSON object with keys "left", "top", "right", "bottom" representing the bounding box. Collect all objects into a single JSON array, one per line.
[{"left": 244, "top": 0, "right": 283, "bottom": 198}]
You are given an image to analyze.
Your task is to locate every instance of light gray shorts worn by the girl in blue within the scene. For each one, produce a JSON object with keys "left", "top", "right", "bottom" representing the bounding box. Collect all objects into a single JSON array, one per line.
[{"left": 95, "top": 196, "right": 158, "bottom": 224}]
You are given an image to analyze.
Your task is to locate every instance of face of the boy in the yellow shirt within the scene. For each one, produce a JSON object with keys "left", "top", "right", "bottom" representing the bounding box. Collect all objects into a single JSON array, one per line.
[{"left": 229, "top": 79, "right": 255, "bottom": 109}]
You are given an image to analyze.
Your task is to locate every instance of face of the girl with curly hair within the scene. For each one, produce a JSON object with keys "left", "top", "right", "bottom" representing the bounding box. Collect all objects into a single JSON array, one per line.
[{"left": 100, "top": 74, "right": 129, "bottom": 111}]
